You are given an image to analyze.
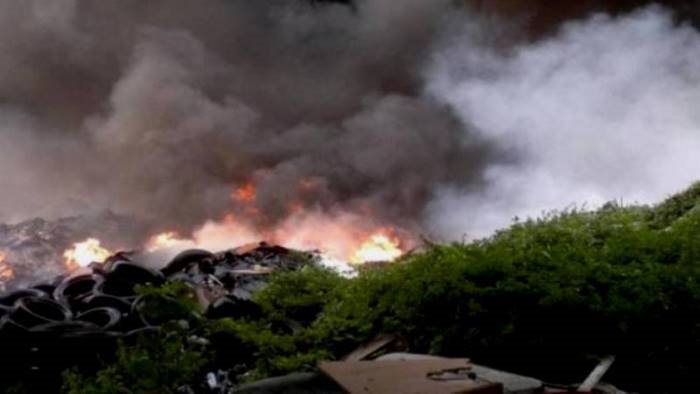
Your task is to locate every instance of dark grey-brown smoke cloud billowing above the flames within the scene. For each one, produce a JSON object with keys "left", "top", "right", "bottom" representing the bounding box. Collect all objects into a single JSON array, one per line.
[{"left": 0, "top": 0, "right": 491, "bottom": 240}]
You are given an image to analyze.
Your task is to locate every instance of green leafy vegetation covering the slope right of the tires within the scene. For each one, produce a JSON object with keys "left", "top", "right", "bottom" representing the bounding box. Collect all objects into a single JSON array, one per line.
[{"left": 60, "top": 184, "right": 700, "bottom": 392}]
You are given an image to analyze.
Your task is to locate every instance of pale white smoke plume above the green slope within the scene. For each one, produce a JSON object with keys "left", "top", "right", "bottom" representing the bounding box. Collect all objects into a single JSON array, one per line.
[{"left": 427, "top": 7, "right": 700, "bottom": 237}]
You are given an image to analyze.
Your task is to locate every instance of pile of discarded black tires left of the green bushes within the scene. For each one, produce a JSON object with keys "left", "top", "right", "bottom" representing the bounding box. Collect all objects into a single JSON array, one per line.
[{"left": 0, "top": 260, "right": 165, "bottom": 392}]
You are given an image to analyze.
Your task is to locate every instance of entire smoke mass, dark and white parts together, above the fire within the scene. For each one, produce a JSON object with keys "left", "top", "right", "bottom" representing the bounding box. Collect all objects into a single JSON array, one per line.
[{"left": 0, "top": 0, "right": 700, "bottom": 252}]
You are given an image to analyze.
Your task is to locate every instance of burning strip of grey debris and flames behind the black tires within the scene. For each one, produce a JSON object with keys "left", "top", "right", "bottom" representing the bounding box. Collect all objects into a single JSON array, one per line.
[{"left": 0, "top": 212, "right": 404, "bottom": 292}]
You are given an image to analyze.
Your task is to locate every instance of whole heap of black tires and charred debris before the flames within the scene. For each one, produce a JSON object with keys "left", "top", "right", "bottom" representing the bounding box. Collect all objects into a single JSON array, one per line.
[{"left": 0, "top": 243, "right": 315, "bottom": 387}]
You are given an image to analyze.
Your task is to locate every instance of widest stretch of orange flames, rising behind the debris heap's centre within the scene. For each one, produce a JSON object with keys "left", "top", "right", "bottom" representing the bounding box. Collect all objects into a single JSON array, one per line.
[{"left": 144, "top": 182, "right": 413, "bottom": 264}]
